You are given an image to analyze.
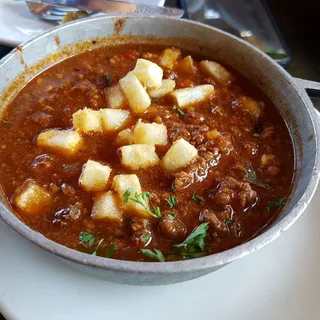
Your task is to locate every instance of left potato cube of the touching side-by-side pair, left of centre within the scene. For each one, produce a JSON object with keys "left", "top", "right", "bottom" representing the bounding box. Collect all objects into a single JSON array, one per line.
[{"left": 72, "top": 108, "right": 103, "bottom": 132}]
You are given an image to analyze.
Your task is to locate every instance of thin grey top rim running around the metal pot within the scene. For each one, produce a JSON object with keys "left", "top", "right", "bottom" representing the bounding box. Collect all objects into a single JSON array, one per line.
[{"left": 0, "top": 14, "right": 320, "bottom": 275}]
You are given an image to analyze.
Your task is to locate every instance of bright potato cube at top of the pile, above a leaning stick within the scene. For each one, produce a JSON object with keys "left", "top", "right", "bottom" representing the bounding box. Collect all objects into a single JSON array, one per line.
[{"left": 133, "top": 59, "right": 163, "bottom": 89}]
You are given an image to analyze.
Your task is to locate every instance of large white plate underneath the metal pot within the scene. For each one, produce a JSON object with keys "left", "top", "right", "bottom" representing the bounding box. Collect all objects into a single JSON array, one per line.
[{"left": 0, "top": 184, "right": 320, "bottom": 320}]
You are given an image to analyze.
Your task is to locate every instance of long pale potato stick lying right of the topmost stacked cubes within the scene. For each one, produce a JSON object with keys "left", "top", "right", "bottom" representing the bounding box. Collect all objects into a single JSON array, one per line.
[{"left": 171, "top": 84, "right": 214, "bottom": 109}]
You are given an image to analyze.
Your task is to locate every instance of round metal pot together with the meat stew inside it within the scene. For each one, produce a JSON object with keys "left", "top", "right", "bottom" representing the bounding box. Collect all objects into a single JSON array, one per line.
[{"left": 0, "top": 17, "right": 317, "bottom": 284}]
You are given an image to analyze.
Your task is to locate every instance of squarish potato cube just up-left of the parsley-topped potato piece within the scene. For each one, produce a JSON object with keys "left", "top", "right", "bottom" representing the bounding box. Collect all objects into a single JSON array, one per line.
[{"left": 79, "top": 160, "right": 111, "bottom": 191}]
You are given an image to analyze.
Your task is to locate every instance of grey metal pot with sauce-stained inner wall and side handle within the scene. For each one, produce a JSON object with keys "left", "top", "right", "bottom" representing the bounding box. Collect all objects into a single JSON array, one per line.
[{"left": 0, "top": 16, "right": 320, "bottom": 285}]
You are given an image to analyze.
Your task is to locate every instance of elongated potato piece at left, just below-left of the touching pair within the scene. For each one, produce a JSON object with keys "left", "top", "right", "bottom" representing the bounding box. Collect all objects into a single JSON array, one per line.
[{"left": 37, "top": 129, "right": 83, "bottom": 155}]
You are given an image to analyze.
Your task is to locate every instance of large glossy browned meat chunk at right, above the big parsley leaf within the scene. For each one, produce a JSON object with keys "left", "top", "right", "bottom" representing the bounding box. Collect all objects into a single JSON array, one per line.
[{"left": 213, "top": 177, "right": 258, "bottom": 208}]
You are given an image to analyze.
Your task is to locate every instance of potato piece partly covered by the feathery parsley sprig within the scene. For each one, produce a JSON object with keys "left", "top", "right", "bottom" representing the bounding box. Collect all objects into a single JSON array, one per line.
[{"left": 112, "top": 174, "right": 150, "bottom": 218}]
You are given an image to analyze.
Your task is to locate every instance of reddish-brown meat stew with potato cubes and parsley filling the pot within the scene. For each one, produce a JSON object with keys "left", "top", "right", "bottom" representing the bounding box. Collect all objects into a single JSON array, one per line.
[{"left": 0, "top": 44, "right": 294, "bottom": 261}]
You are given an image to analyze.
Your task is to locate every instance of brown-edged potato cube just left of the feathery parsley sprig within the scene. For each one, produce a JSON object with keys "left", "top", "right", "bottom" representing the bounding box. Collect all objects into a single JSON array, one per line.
[{"left": 91, "top": 191, "right": 122, "bottom": 221}]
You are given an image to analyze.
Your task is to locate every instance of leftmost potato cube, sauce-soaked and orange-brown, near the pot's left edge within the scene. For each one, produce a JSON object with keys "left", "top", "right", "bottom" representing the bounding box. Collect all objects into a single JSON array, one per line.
[{"left": 13, "top": 180, "right": 51, "bottom": 216}]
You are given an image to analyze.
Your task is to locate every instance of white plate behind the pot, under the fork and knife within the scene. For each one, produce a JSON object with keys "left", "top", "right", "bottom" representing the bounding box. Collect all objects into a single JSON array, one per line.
[{"left": 0, "top": 0, "right": 165, "bottom": 47}]
